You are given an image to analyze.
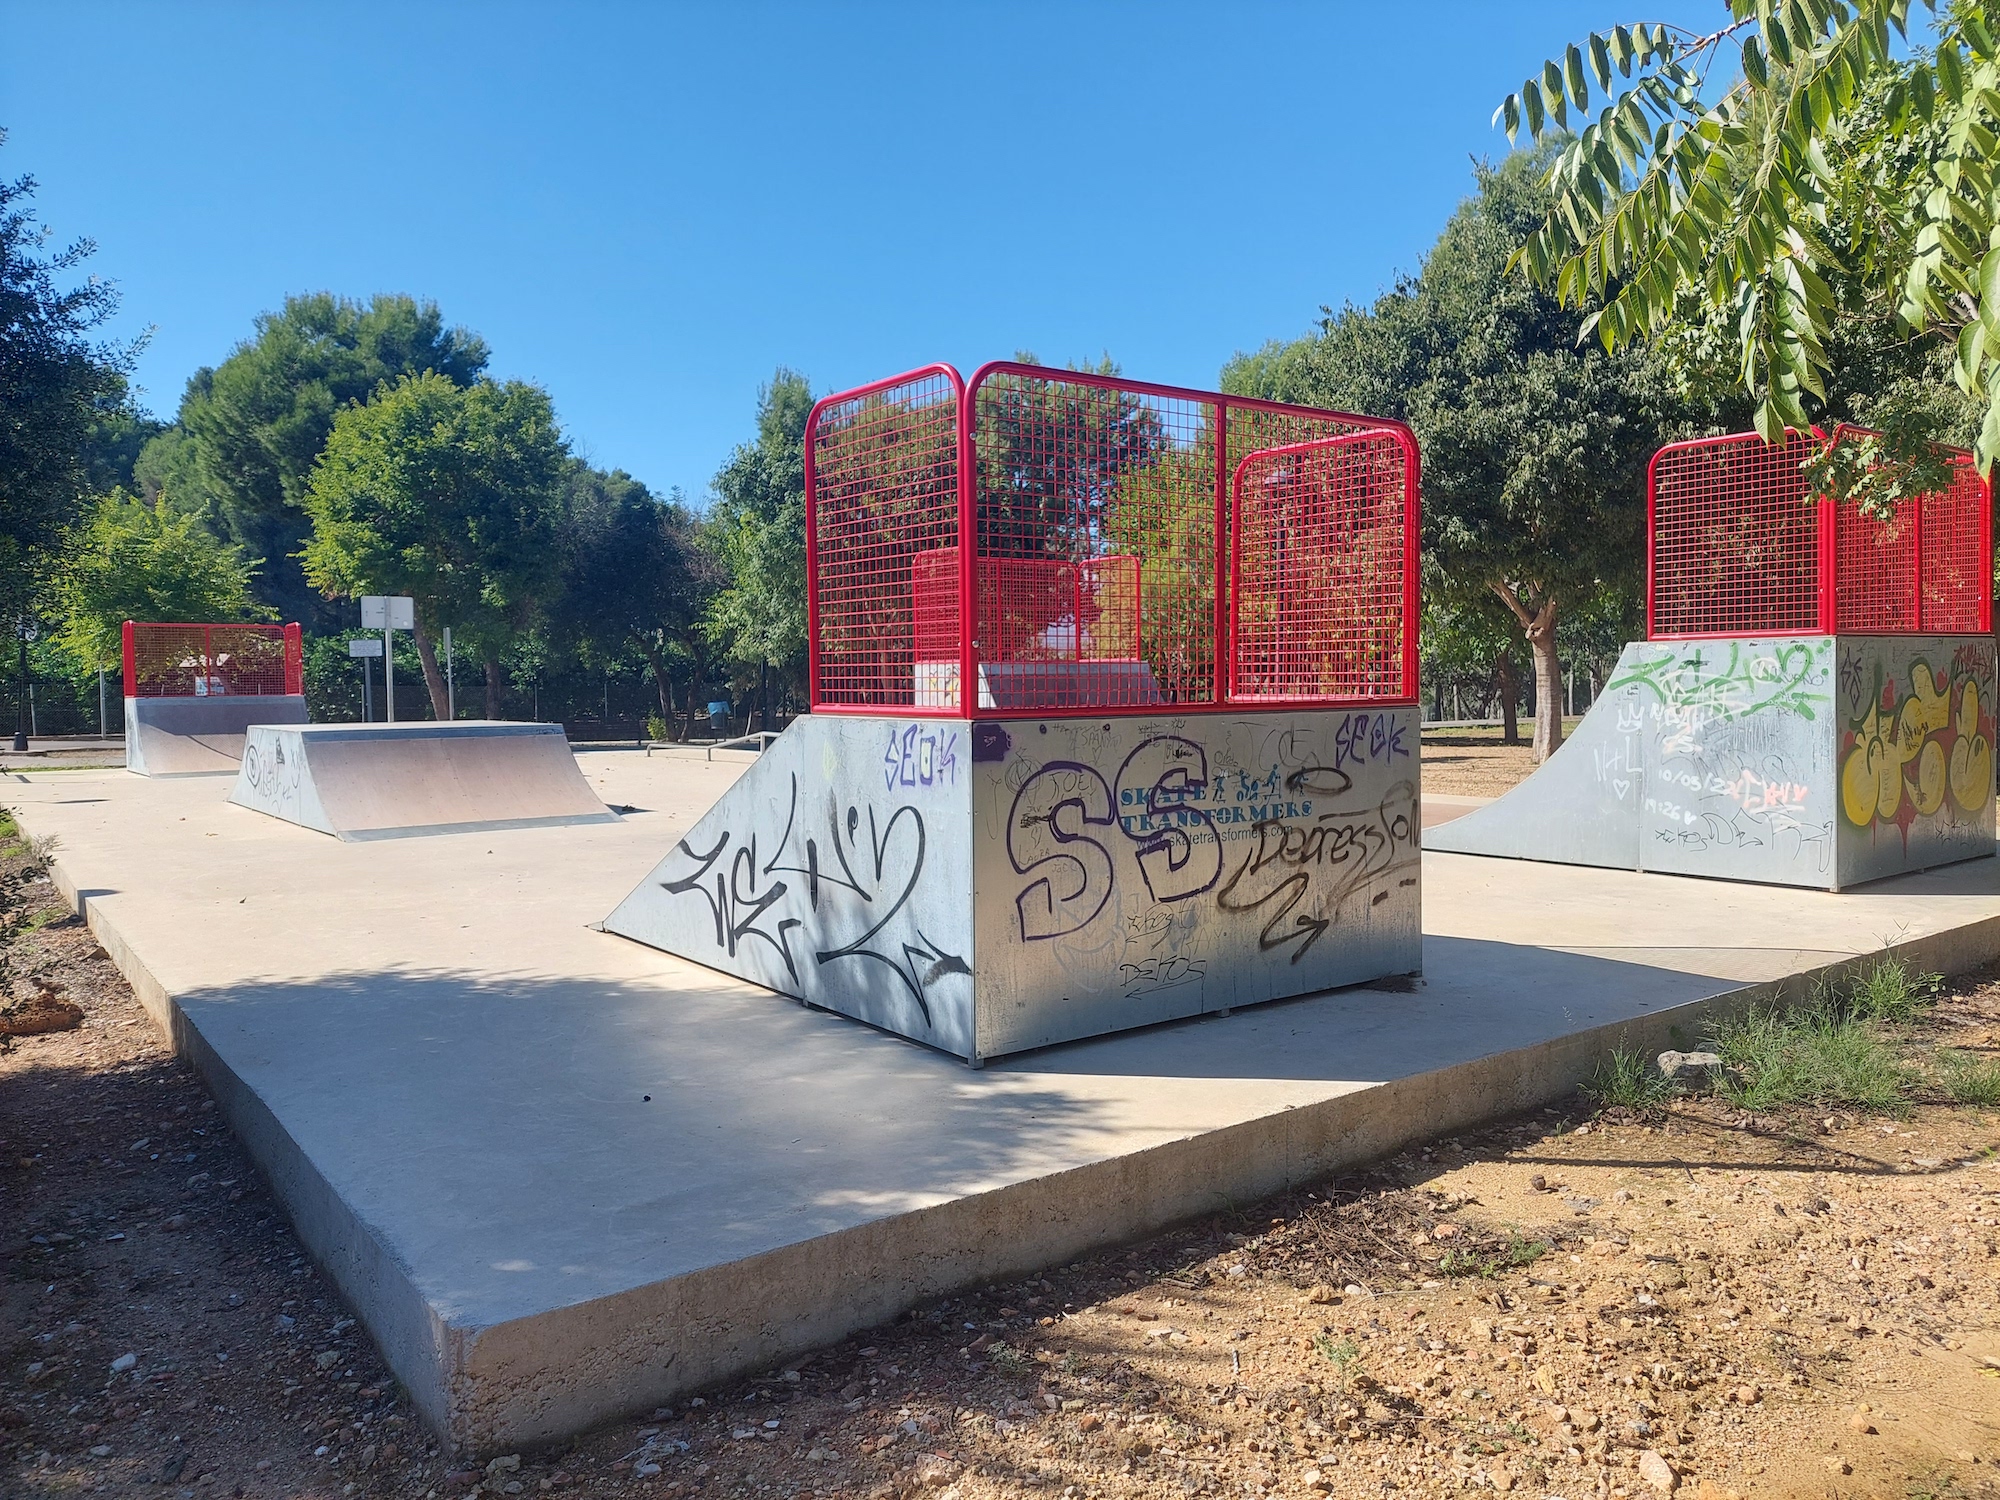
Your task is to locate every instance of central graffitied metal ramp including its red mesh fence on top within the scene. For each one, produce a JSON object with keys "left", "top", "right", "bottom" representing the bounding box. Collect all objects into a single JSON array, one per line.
[{"left": 604, "top": 362, "right": 1422, "bottom": 1062}]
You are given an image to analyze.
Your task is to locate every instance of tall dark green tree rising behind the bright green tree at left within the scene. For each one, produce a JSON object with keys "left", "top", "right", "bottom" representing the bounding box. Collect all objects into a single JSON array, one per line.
[{"left": 138, "top": 292, "right": 486, "bottom": 618}]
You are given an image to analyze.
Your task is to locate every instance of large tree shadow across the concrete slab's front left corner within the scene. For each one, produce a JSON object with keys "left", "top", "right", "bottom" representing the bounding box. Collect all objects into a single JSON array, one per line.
[{"left": 180, "top": 970, "right": 1114, "bottom": 1324}]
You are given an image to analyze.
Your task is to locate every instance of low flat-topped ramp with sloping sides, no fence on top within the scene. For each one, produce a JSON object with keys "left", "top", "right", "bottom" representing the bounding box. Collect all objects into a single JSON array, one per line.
[{"left": 230, "top": 720, "right": 618, "bottom": 842}]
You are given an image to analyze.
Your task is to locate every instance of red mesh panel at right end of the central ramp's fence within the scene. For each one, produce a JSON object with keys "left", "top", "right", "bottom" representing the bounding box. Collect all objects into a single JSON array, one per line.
[{"left": 1230, "top": 430, "right": 1414, "bottom": 702}]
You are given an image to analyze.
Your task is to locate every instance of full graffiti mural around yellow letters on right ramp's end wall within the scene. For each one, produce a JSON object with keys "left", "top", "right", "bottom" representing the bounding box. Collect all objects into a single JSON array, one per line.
[{"left": 1840, "top": 648, "right": 1994, "bottom": 838}]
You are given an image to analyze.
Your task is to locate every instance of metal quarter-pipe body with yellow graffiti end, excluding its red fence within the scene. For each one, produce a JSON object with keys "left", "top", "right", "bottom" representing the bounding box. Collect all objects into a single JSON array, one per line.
[{"left": 1424, "top": 634, "right": 1996, "bottom": 890}]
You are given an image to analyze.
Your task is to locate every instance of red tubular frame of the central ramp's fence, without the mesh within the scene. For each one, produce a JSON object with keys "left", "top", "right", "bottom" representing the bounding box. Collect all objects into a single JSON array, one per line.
[{"left": 804, "top": 360, "right": 1422, "bottom": 718}]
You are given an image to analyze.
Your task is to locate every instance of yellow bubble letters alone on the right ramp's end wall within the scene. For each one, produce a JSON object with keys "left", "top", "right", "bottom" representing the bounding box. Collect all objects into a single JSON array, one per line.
[{"left": 1840, "top": 662, "right": 1994, "bottom": 826}]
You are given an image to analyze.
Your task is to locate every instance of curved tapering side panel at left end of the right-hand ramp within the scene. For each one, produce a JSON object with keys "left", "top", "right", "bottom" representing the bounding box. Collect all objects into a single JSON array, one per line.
[{"left": 1424, "top": 642, "right": 1646, "bottom": 870}]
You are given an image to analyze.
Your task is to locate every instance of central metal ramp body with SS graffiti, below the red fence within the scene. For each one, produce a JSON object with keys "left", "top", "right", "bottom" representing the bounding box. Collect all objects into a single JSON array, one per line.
[{"left": 604, "top": 708, "right": 1422, "bottom": 1062}]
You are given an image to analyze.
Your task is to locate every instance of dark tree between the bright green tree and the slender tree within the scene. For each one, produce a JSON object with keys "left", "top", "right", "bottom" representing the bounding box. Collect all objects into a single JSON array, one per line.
[{"left": 558, "top": 464, "right": 722, "bottom": 732}]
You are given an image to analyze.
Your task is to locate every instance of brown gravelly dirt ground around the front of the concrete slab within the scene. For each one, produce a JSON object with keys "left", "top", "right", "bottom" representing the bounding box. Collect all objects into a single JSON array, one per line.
[{"left": 0, "top": 824, "right": 2000, "bottom": 1500}]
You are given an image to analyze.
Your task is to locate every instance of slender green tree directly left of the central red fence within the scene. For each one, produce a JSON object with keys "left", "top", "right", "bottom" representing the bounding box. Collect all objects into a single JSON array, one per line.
[{"left": 708, "top": 366, "right": 812, "bottom": 728}]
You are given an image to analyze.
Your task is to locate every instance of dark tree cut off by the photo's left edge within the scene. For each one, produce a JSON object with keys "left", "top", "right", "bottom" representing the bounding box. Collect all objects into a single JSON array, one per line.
[{"left": 0, "top": 130, "right": 134, "bottom": 748}]
